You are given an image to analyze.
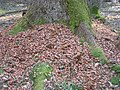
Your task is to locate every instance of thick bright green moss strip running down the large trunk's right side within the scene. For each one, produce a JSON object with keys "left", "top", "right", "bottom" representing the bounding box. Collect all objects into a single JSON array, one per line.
[{"left": 66, "top": 0, "right": 91, "bottom": 32}]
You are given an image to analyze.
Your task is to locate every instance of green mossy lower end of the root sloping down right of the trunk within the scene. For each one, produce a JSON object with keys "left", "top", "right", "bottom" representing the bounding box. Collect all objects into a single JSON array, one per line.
[{"left": 90, "top": 46, "right": 108, "bottom": 64}]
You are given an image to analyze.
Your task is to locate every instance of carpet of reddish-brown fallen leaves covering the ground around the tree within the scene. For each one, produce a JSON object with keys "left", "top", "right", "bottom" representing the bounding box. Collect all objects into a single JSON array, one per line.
[{"left": 0, "top": 17, "right": 120, "bottom": 90}]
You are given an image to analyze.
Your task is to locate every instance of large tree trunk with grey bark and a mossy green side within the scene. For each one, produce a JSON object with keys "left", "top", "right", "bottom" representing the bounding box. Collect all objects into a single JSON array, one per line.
[{"left": 27, "top": 0, "right": 95, "bottom": 45}]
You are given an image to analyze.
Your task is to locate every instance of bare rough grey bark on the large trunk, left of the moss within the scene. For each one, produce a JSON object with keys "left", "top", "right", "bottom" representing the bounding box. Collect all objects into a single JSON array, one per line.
[{"left": 29, "top": 0, "right": 68, "bottom": 23}]
